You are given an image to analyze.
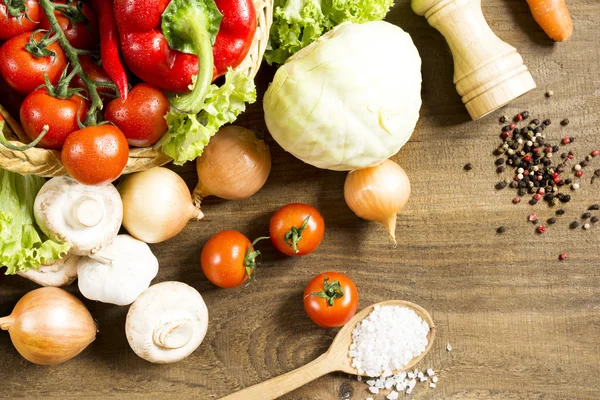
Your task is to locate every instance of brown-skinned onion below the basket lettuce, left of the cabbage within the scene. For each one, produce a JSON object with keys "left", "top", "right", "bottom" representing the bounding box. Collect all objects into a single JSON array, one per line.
[{"left": 194, "top": 125, "right": 271, "bottom": 204}]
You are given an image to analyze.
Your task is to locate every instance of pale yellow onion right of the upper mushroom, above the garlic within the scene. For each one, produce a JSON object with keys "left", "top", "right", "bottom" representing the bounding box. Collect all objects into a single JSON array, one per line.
[{"left": 117, "top": 167, "right": 204, "bottom": 243}]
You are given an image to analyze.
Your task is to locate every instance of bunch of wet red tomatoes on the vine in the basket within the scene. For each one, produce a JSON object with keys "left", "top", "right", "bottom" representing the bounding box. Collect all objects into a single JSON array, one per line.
[{"left": 0, "top": 0, "right": 169, "bottom": 185}]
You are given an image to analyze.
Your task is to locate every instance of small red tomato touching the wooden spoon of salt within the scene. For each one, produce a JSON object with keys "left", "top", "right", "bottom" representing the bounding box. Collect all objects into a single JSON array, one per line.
[{"left": 304, "top": 272, "right": 358, "bottom": 328}]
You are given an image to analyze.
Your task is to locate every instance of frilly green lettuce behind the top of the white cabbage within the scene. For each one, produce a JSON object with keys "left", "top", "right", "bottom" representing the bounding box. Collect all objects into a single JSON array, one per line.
[{"left": 265, "top": 0, "right": 394, "bottom": 64}]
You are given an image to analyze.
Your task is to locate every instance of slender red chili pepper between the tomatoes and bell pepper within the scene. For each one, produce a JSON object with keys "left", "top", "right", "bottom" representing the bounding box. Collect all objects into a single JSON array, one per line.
[{"left": 92, "top": 0, "right": 129, "bottom": 100}]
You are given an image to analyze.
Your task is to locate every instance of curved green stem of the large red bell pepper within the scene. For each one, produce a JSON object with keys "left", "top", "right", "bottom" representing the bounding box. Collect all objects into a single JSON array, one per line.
[{"left": 170, "top": 14, "right": 214, "bottom": 114}]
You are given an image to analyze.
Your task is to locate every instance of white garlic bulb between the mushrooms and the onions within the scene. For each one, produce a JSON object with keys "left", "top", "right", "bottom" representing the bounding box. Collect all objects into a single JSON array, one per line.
[{"left": 77, "top": 235, "right": 158, "bottom": 306}]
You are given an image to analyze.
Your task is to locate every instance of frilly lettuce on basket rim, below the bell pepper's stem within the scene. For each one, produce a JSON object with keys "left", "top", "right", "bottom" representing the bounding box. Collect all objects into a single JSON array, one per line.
[{"left": 157, "top": 69, "right": 256, "bottom": 165}]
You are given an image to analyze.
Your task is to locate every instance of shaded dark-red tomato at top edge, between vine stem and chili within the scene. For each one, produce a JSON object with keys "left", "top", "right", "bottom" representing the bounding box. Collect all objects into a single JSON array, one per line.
[{"left": 40, "top": 0, "right": 100, "bottom": 50}]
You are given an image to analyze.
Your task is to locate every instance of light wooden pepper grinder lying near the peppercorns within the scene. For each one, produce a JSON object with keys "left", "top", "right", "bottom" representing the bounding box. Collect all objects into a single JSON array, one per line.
[{"left": 411, "top": 0, "right": 535, "bottom": 119}]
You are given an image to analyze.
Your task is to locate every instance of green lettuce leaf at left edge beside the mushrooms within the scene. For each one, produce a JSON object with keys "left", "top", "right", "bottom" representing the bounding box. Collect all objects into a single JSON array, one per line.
[{"left": 0, "top": 169, "right": 70, "bottom": 275}]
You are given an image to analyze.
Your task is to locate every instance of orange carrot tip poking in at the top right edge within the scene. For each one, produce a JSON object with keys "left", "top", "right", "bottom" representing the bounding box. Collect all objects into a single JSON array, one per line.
[{"left": 527, "top": 0, "right": 573, "bottom": 42}]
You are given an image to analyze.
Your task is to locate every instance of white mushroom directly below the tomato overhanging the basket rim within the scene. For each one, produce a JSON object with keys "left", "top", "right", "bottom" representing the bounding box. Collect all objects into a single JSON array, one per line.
[{"left": 33, "top": 176, "right": 123, "bottom": 256}]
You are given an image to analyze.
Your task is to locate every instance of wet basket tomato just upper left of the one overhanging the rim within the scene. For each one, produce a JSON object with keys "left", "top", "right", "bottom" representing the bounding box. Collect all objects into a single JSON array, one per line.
[{"left": 20, "top": 88, "right": 88, "bottom": 149}]
